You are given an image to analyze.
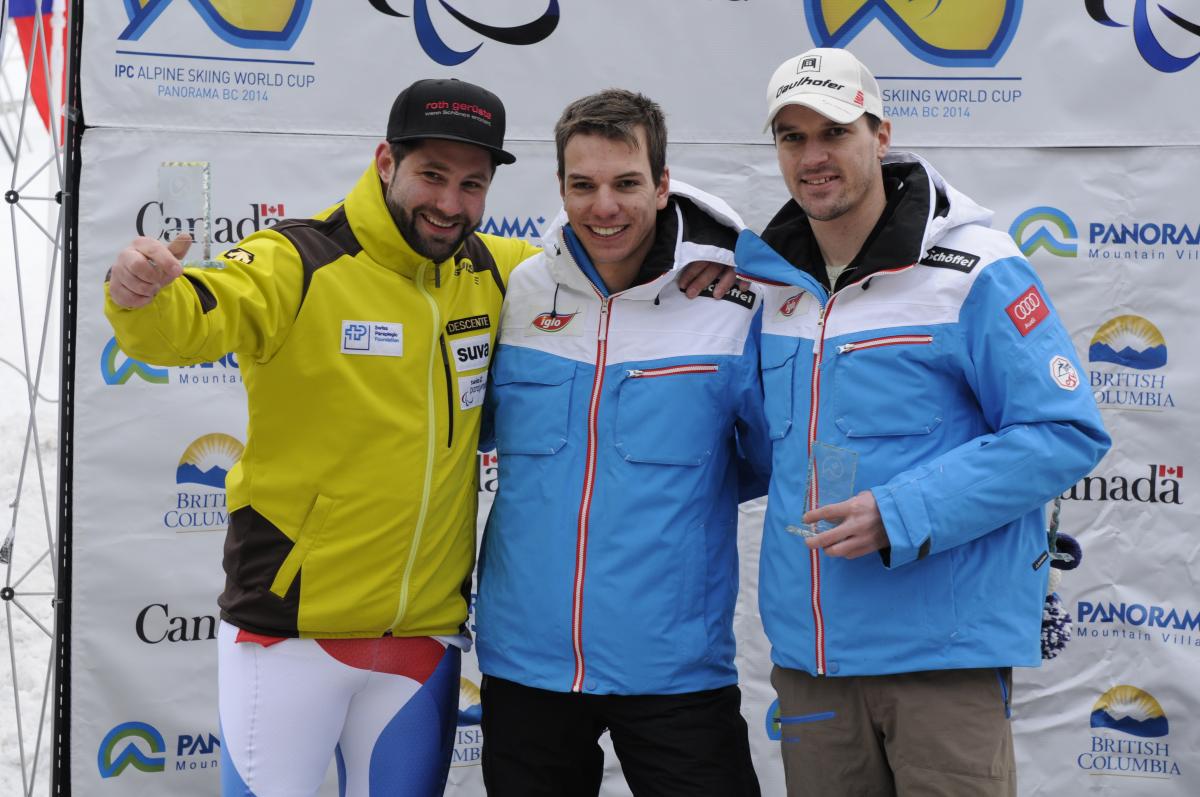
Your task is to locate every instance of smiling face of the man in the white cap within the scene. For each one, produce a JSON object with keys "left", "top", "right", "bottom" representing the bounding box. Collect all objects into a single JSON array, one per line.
[{"left": 772, "top": 106, "right": 892, "bottom": 223}]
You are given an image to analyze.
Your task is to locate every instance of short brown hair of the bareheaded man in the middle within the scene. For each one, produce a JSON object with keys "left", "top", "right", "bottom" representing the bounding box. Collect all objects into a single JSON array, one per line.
[{"left": 554, "top": 89, "right": 667, "bottom": 182}]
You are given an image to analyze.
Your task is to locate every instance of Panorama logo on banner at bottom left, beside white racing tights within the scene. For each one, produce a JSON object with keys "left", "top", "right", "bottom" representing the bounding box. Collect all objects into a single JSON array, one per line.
[{"left": 96, "top": 721, "right": 221, "bottom": 778}]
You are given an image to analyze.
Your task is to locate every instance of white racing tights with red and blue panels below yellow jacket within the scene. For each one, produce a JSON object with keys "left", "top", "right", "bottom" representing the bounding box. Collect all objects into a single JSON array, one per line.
[{"left": 217, "top": 622, "right": 461, "bottom": 797}]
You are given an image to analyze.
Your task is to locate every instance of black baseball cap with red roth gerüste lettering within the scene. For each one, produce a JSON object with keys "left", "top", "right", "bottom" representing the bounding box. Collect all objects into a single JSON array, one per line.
[{"left": 388, "top": 78, "right": 517, "bottom": 163}]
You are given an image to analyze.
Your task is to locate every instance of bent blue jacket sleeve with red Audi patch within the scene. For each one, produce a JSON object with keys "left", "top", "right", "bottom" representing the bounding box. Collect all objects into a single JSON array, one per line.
[{"left": 872, "top": 257, "right": 1110, "bottom": 568}]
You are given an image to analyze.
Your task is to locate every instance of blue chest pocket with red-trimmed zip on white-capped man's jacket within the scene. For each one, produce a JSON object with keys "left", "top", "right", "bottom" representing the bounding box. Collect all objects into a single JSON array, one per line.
[{"left": 832, "top": 334, "right": 944, "bottom": 437}]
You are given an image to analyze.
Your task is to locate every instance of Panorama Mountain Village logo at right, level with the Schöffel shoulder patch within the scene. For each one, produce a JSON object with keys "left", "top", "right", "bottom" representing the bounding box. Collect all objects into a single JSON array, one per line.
[{"left": 1008, "top": 205, "right": 1200, "bottom": 262}]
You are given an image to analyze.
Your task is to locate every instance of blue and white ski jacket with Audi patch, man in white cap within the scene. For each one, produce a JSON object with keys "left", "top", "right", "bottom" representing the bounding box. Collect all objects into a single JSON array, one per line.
[{"left": 737, "top": 154, "right": 1110, "bottom": 676}]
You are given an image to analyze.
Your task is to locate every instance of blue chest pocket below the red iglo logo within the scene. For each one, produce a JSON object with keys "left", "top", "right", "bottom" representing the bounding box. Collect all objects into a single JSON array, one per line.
[{"left": 492, "top": 350, "right": 575, "bottom": 456}]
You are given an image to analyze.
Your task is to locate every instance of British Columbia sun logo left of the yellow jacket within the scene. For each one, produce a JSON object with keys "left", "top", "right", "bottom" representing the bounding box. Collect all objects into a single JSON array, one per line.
[{"left": 162, "top": 432, "right": 242, "bottom": 532}]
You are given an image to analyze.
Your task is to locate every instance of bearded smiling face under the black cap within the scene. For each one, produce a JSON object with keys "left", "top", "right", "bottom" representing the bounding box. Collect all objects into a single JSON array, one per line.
[{"left": 376, "top": 138, "right": 494, "bottom": 263}]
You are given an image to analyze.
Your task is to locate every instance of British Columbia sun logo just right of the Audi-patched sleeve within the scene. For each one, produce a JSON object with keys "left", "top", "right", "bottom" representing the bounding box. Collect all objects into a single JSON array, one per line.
[{"left": 1087, "top": 314, "right": 1176, "bottom": 412}]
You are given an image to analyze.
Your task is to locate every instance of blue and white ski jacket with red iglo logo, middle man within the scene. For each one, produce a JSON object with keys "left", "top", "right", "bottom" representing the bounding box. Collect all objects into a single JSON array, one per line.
[{"left": 475, "top": 181, "right": 769, "bottom": 695}]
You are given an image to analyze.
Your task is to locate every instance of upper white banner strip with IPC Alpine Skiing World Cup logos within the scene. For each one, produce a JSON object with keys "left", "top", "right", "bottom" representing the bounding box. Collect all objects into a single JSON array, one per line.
[{"left": 83, "top": 0, "right": 1200, "bottom": 146}]
